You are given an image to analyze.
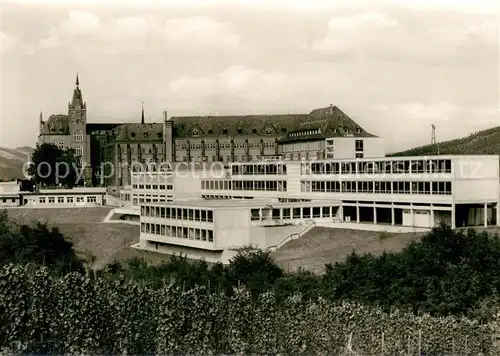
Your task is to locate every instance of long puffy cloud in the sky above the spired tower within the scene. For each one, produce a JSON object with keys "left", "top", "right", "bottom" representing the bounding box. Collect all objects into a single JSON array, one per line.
[{"left": 39, "top": 10, "right": 239, "bottom": 54}]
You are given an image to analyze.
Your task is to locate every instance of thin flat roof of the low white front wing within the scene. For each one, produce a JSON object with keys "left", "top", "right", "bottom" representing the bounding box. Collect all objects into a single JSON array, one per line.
[{"left": 141, "top": 199, "right": 341, "bottom": 209}]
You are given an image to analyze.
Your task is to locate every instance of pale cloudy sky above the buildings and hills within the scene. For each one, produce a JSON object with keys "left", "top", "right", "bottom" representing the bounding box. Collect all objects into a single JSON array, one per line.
[{"left": 0, "top": 0, "right": 500, "bottom": 152}]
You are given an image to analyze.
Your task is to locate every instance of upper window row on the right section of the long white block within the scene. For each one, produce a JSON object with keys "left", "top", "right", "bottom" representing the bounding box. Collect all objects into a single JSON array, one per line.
[{"left": 302, "top": 159, "right": 451, "bottom": 175}]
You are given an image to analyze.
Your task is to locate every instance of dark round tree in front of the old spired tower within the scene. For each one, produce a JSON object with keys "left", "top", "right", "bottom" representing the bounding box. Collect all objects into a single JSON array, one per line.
[{"left": 28, "top": 143, "right": 83, "bottom": 188}]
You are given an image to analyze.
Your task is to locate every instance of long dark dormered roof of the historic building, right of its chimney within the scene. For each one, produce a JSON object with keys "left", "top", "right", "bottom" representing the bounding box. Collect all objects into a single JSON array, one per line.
[{"left": 172, "top": 106, "right": 374, "bottom": 142}]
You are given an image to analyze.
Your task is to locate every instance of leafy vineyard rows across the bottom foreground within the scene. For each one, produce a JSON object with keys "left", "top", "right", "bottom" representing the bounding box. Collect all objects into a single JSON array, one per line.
[{"left": 0, "top": 264, "right": 499, "bottom": 355}]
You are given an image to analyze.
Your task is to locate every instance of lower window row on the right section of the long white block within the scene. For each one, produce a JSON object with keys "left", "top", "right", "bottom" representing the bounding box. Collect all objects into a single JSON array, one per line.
[{"left": 301, "top": 181, "right": 452, "bottom": 195}]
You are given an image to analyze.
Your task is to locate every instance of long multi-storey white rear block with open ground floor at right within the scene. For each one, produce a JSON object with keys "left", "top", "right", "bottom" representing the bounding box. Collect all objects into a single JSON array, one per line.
[{"left": 201, "top": 156, "right": 500, "bottom": 228}]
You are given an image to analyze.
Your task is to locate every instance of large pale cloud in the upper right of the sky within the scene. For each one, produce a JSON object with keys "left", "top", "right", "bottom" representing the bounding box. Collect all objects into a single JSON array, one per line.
[{"left": 311, "top": 12, "right": 498, "bottom": 63}]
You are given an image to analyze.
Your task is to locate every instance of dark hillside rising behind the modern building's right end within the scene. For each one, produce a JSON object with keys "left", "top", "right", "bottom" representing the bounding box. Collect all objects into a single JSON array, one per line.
[{"left": 388, "top": 126, "right": 500, "bottom": 156}]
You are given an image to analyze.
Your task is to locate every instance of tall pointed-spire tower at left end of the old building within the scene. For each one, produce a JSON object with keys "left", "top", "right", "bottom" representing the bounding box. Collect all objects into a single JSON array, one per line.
[{"left": 68, "top": 73, "right": 90, "bottom": 184}]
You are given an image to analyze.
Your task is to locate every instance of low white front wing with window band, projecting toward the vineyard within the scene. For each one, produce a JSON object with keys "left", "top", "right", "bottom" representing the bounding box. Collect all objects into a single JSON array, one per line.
[{"left": 139, "top": 200, "right": 340, "bottom": 260}]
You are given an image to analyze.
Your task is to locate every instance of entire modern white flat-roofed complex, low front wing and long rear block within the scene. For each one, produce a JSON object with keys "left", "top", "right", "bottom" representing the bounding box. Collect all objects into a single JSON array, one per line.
[{"left": 132, "top": 156, "right": 500, "bottom": 260}]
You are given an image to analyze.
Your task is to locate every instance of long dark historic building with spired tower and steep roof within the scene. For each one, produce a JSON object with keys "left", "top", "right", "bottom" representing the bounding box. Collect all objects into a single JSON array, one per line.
[{"left": 38, "top": 75, "right": 385, "bottom": 186}]
